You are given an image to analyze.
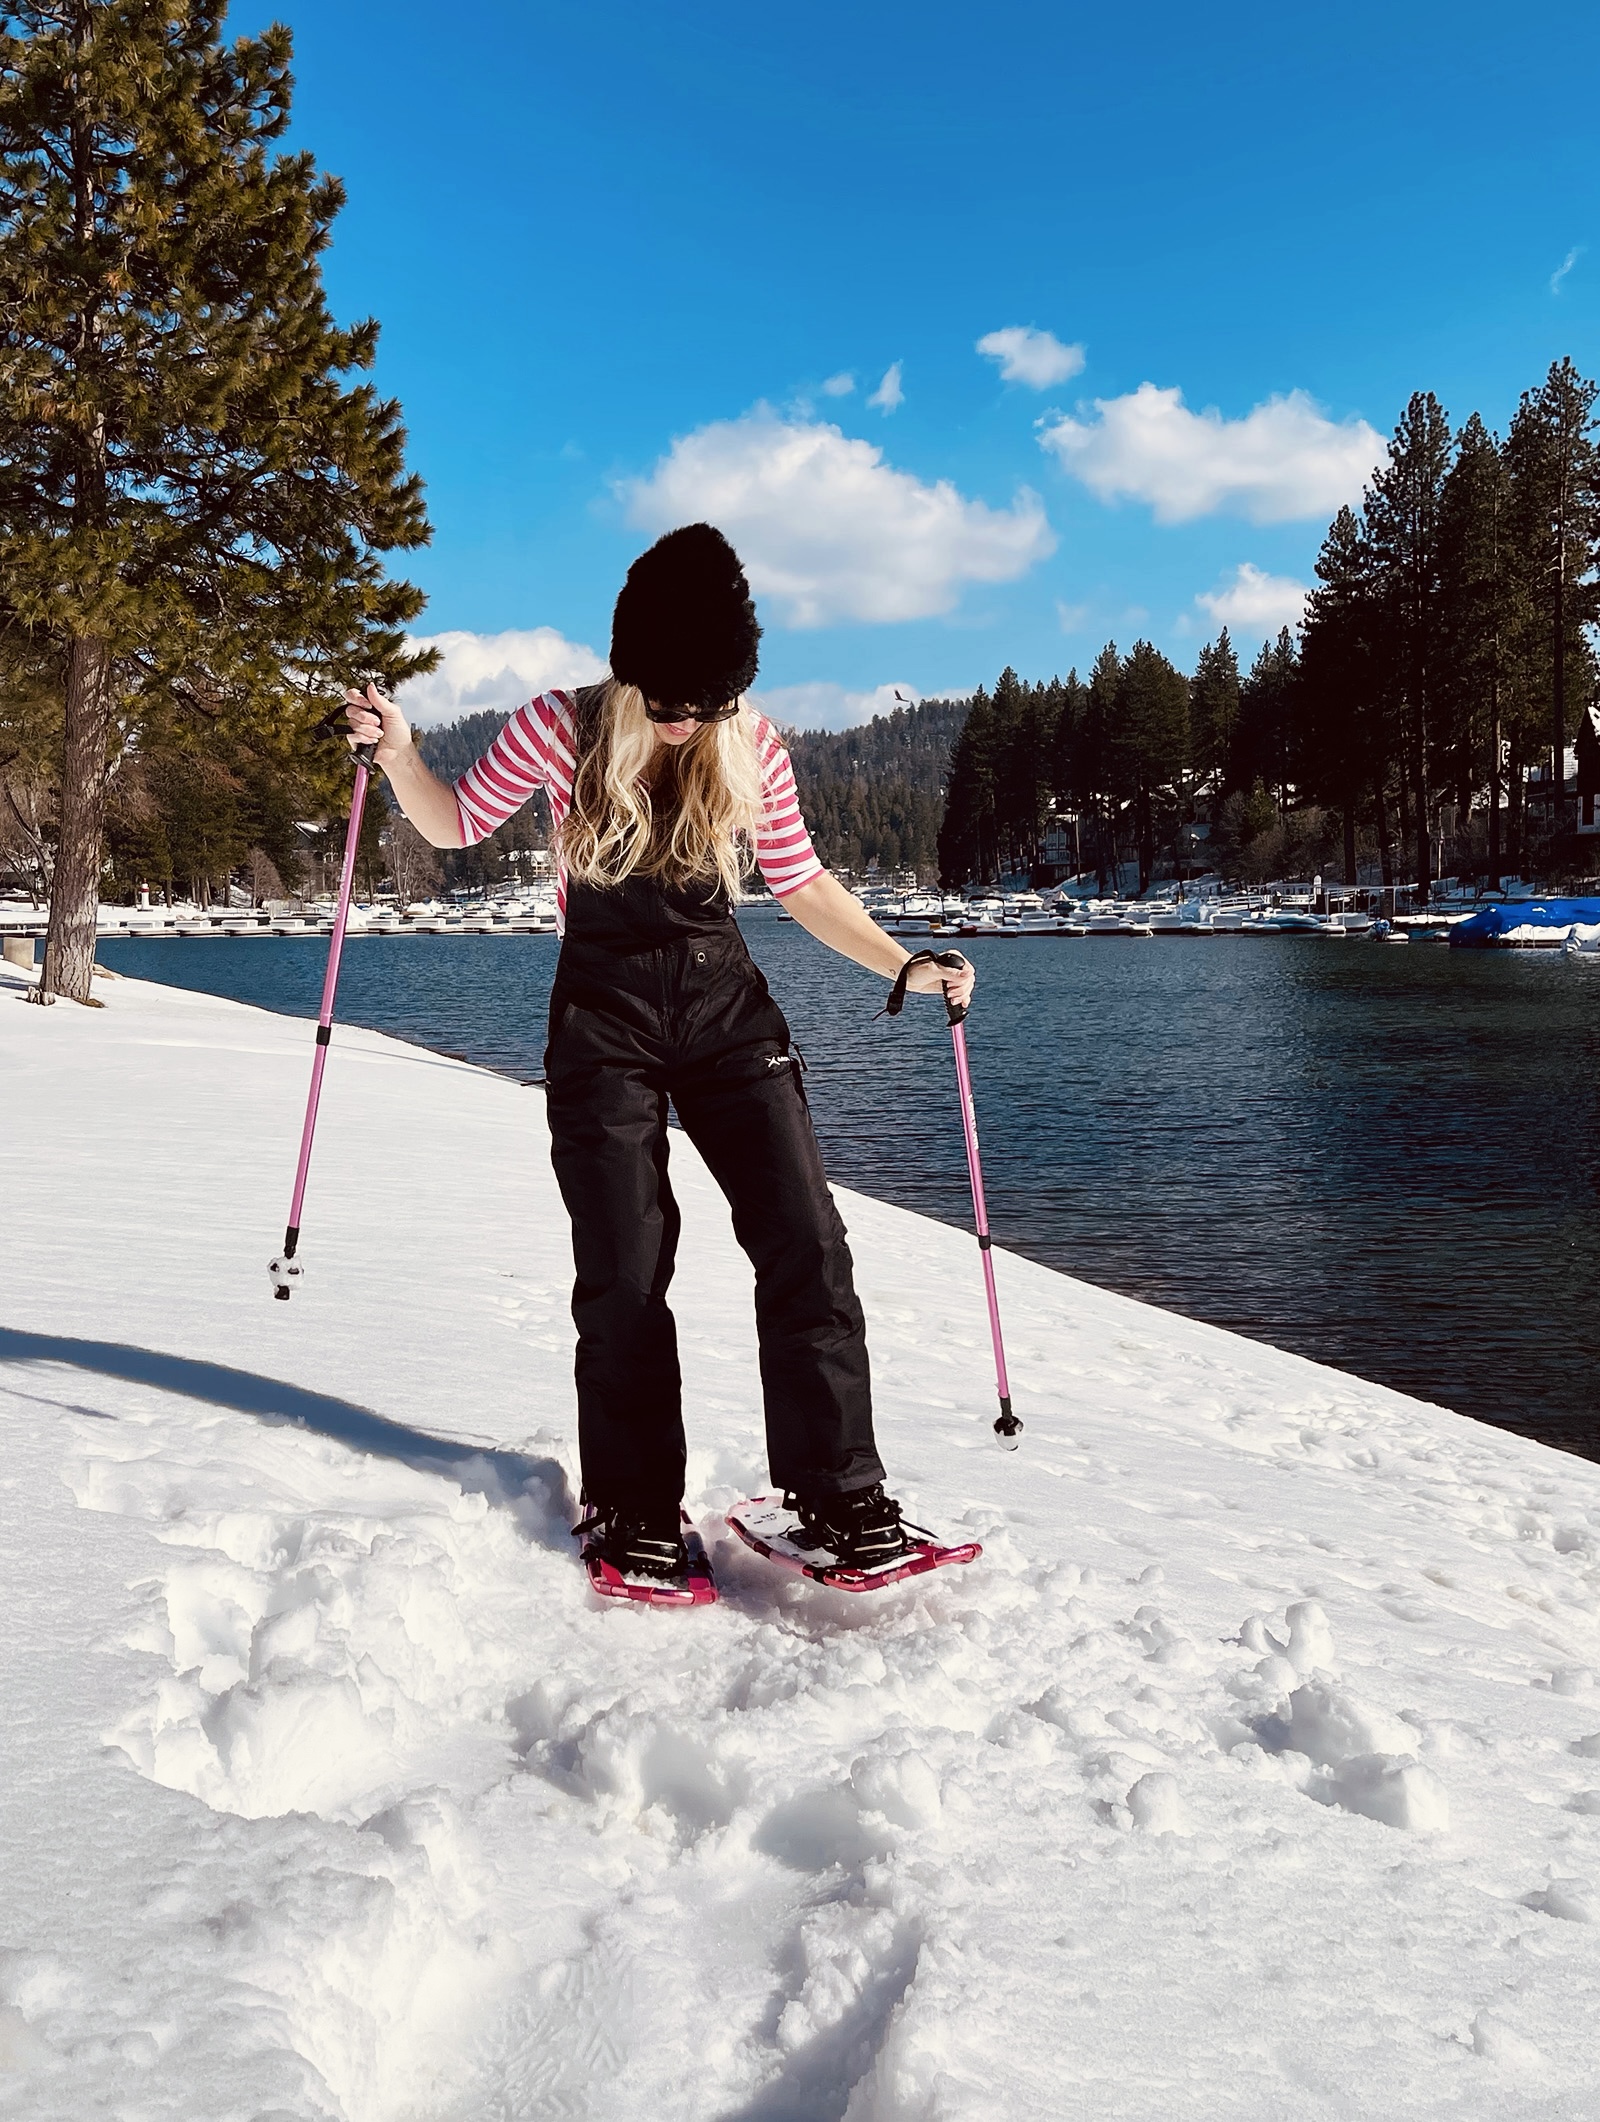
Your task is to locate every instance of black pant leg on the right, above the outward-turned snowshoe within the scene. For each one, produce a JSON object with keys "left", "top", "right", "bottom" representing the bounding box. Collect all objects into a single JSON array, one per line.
[{"left": 673, "top": 1039, "right": 883, "bottom": 1496}]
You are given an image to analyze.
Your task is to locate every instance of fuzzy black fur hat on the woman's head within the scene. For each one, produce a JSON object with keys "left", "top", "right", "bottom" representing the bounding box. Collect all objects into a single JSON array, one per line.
[{"left": 611, "top": 524, "right": 762, "bottom": 709}]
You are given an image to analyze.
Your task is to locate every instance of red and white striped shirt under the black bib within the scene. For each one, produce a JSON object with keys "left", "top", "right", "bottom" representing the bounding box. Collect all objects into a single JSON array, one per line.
[{"left": 456, "top": 692, "right": 823, "bottom": 929}]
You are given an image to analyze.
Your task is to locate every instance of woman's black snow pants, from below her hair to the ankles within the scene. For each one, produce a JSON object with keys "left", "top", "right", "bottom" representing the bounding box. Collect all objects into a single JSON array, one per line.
[{"left": 545, "top": 879, "right": 883, "bottom": 1509}]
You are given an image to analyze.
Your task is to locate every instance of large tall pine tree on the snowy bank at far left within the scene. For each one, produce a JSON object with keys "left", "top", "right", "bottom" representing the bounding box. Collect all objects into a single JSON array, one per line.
[{"left": 0, "top": 0, "right": 429, "bottom": 1002}]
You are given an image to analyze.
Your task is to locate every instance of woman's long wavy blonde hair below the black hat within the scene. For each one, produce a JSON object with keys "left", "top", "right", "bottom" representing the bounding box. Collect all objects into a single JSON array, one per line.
[{"left": 558, "top": 679, "right": 762, "bottom": 900}]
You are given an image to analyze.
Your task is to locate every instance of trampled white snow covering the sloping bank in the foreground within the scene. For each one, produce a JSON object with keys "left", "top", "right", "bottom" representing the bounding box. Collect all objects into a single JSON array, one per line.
[{"left": 0, "top": 968, "right": 1600, "bottom": 2122}]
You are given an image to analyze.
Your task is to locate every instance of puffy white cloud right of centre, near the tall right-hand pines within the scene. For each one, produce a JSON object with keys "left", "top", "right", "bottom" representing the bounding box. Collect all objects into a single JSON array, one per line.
[{"left": 1040, "top": 384, "right": 1386, "bottom": 524}]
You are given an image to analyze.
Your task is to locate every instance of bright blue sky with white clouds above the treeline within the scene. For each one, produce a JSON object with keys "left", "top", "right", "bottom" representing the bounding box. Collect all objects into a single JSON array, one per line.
[{"left": 252, "top": 0, "right": 1600, "bottom": 724}]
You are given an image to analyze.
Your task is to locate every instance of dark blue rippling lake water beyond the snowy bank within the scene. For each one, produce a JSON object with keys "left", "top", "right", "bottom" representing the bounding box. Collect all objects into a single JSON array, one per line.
[{"left": 100, "top": 908, "right": 1600, "bottom": 1458}]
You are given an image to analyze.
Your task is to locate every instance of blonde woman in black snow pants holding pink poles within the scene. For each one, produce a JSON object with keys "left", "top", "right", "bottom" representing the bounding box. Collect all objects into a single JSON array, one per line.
[{"left": 346, "top": 524, "right": 974, "bottom": 1587}]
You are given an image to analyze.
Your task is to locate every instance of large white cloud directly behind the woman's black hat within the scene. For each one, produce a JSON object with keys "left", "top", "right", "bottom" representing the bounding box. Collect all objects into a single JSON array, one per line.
[{"left": 622, "top": 405, "right": 1055, "bottom": 626}]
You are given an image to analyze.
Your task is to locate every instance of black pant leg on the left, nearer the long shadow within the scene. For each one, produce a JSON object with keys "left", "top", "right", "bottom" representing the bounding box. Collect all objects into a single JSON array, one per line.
[{"left": 545, "top": 1004, "right": 685, "bottom": 1507}]
